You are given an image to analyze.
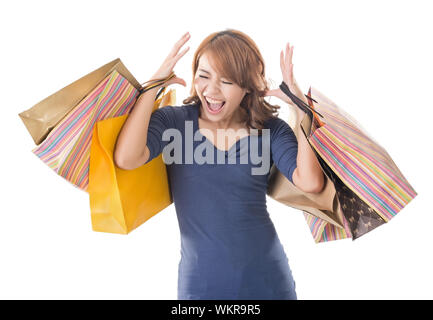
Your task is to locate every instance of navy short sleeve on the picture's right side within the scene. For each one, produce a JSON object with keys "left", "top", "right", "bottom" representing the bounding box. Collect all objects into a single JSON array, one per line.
[{"left": 269, "top": 117, "right": 298, "bottom": 183}]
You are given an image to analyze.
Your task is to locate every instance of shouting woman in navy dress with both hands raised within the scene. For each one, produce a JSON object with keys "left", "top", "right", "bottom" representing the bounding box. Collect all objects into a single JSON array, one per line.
[{"left": 114, "top": 29, "right": 324, "bottom": 299}]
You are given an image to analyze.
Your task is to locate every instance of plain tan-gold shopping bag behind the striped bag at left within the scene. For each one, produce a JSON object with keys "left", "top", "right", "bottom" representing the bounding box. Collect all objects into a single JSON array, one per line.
[{"left": 19, "top": 59, "right": 141, "bottom": 145}]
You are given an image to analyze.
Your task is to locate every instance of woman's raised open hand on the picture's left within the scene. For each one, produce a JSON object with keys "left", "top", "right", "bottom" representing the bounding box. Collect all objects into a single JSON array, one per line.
[{"left": 152, "top": 32, "right": 191, "bottom": 87}]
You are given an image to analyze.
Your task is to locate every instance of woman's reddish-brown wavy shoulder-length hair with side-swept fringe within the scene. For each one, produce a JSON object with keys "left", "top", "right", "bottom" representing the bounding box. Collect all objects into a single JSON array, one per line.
[{"left": 183, "top": 29, "right": 280, "bottom": 134}]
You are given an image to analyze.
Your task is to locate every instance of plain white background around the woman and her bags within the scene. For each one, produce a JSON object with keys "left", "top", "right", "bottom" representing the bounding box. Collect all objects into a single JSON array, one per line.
[{"left": 0, "top": 0, "right": 433, "bottom": 299}]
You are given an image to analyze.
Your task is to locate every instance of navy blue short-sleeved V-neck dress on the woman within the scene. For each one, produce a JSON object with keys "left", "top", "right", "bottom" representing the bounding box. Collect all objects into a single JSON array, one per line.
[{"left": 147, "top": 104, "right": 298, "bottom": 300}]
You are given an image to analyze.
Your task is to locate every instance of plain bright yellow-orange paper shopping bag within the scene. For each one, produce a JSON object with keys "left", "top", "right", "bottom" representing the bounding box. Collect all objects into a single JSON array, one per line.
[{"left": 88, "top": 90, "right": 175, "bottom": 234}]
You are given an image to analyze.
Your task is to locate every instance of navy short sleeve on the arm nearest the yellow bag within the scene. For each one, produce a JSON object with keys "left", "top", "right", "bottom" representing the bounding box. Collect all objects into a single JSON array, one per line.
[{"left": 146, "top": 106, "right": 176, "bottom": 163}]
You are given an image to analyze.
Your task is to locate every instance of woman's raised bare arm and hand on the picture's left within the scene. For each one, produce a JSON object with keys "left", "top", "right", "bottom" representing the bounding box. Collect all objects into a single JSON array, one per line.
[{"left": 113, "top": 33, "right": 190, "bottom": 170}]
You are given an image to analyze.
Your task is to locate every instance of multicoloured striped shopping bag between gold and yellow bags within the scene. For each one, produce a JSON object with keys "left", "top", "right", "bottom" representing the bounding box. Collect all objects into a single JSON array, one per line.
[{"left": 32, "top": 70, "right": 139, "bottom": 191}]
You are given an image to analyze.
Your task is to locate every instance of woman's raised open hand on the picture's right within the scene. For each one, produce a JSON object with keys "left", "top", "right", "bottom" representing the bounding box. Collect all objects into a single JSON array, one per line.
[{"left": 265, "top": 43, "right": 302, "bottom": 104}]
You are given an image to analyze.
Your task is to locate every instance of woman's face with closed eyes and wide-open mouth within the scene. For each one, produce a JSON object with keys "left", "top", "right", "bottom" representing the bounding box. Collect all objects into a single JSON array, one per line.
[{"left": 194, "top": 53, "right": 247, "bottom": 121}]
